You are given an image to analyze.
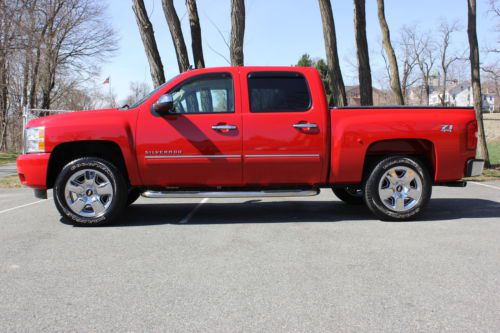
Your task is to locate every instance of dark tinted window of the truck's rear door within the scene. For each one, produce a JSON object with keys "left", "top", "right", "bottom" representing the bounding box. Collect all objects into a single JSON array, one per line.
[{"left": 247, "top": 72, "right": 312, "bottom": 113}]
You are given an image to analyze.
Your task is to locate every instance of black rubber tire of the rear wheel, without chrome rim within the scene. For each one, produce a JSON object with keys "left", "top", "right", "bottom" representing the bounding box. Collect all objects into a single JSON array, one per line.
[{"left": 364, "top": 156, "right": 432, "bottom": 221}]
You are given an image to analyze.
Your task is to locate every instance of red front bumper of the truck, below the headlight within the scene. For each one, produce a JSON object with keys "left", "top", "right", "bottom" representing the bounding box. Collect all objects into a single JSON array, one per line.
[{"left": 17, "top": 153, "right": 50, "bottom": 190}]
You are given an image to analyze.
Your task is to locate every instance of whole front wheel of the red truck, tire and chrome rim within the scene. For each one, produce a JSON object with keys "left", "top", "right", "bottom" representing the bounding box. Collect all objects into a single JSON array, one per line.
[{"left": 53, "top": 157, "right": 128, "bottom": 226}]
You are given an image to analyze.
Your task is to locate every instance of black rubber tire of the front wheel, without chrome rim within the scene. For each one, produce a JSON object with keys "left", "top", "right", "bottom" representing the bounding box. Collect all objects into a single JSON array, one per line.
[{"left": 53, "top": 157, "right": 128, "bottom": 226}]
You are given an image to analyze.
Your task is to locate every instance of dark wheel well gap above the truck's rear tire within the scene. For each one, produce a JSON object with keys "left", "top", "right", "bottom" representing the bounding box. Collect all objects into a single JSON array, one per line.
[{"left": 363, "top": 139, "right": 436, "bottom": 179}]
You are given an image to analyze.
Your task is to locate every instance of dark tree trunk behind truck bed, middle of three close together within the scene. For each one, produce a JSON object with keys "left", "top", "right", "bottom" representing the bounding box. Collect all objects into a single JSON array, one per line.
[{"left": 354, "top": 0, "right": 373, "bottom": 105}]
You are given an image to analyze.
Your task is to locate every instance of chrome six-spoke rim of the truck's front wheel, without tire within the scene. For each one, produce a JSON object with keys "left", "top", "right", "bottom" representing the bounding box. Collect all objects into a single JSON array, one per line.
[{"left": 64, "top": 169, "right": 114, "bottom": 217}]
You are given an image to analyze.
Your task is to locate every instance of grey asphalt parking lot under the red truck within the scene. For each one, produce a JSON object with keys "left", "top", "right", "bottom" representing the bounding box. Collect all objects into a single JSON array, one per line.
[{"left": 0, "top": 182, "right": 500, "bottom": 332}]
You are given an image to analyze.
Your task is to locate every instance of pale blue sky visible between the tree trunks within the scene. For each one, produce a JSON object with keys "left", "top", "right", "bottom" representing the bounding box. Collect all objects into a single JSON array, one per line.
[{"left": 96, "top": 0, "right": 497, "bottom": 99}]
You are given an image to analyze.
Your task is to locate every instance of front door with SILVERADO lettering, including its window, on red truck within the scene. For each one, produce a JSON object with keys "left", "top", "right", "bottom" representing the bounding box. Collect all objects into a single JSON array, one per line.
[{"left": 137, "top": 73, "right": 242, "bottom": 187}]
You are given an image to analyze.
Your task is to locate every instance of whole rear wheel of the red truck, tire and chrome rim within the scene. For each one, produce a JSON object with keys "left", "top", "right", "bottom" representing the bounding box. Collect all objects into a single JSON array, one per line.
[{"left": 365, "top": 156, "right": 432, "bottom": 221}]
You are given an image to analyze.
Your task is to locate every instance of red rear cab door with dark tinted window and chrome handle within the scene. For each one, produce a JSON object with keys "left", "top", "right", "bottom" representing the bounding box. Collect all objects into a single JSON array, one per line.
[{"left": 240, "top": 68, "right": 327, "bottom": 185}]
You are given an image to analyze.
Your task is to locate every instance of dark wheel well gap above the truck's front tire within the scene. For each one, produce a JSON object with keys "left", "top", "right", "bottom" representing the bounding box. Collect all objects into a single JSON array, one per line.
[{"left": 47, "top": 141, "right": 130, "bottom": 188}]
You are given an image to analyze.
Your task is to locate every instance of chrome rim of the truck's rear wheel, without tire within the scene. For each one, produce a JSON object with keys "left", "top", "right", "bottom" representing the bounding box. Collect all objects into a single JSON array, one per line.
[{"left": 378, "top": 166, "right": 422, "bottom": 212}]
